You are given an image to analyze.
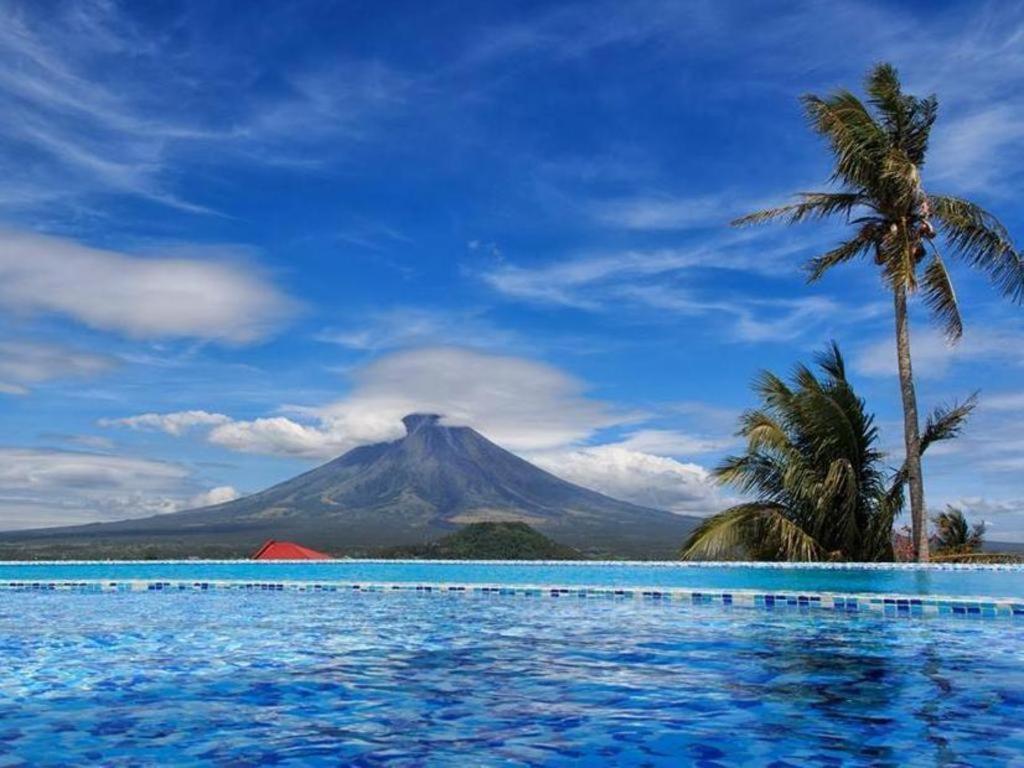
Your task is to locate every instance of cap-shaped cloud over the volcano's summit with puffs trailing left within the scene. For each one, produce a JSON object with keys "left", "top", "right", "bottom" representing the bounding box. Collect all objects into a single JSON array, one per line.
[{"left": 105, "top": 347, "right": 638, "bottom": 458}]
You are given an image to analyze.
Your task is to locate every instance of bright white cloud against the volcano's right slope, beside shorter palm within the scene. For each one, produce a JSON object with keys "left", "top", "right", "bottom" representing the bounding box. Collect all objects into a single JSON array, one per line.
[{"left": 527, "top": 445, "right": 721, "bottom": 515}]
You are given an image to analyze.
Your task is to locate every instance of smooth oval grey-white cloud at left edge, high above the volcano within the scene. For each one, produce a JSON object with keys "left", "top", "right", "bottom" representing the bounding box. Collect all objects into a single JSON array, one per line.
[{"left": 0, "top": 230, "right": 293, "bottom": 343}]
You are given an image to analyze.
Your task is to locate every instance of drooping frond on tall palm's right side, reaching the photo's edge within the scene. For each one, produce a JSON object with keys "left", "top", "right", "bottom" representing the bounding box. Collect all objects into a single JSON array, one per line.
[{"left": 929, "top": 195, "right": 1024, "bottom": 303}]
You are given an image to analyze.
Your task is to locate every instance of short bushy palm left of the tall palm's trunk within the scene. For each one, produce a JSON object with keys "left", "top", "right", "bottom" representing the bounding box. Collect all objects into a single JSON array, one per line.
[{"left": 682, "top": 343, "right": 974, "bottom": 561}]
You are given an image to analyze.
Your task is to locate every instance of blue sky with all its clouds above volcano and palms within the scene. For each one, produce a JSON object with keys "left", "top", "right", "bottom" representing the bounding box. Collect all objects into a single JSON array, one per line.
[{"left": 0, "top": 0, "right": 1024, "bottom": 541}]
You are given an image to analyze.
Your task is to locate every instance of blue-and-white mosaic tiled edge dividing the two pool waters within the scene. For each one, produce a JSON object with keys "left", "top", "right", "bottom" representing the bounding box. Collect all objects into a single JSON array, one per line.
[{"left": 0, "top": 580, "right": 1024, "bottom": 621}]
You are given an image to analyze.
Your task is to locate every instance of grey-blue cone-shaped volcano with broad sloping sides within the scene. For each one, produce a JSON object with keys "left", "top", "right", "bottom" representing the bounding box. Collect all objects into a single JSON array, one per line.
[{"left": 0, "top": 414, "right": 698, "bottom": 558}]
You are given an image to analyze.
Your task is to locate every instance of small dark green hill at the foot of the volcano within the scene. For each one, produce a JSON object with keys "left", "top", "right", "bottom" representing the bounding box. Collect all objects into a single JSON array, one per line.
[{"left": 385, "top": 522, "right": 584, "bottom": 560}]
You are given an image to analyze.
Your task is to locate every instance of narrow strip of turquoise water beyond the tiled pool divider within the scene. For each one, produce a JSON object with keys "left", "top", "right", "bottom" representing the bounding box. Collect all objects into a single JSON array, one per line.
[{"left": 0, "top": 560, "right": 1024, "bottom": 598}]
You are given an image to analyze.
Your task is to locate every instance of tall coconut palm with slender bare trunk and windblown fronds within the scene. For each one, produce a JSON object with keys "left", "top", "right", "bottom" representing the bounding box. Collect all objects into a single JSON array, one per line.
[{"left": 733, "top": 63, "right": 1024, "bottom": 561}]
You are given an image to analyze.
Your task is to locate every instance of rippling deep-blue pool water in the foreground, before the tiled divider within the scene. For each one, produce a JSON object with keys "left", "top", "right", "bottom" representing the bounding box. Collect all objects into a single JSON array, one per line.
[{"left": 0, "top": 589, "right": 1024, "bottom": 766}]
